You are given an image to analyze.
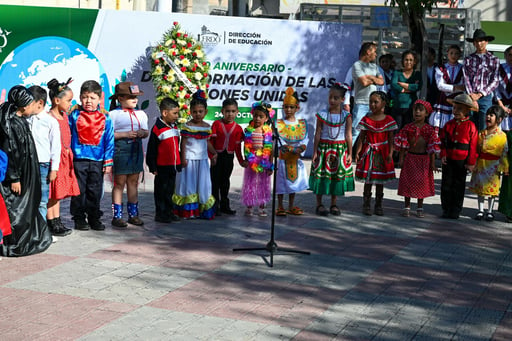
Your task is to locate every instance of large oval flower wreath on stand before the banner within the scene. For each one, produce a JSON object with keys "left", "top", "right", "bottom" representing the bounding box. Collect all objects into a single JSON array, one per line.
[{"left": 151, "top": 21, "right": 210, "bottom": 123}]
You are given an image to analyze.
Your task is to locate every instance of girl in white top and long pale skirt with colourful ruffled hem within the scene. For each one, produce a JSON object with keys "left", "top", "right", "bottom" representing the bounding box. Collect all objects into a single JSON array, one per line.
[{"left": 172, "top": 90, "right": 217, "bottom": 219}]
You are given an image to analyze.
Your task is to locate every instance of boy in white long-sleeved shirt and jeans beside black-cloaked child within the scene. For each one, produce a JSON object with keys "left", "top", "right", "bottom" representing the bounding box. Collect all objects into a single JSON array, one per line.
[{"left": 28, "top": 85, "right": 62, "bottom": 230}]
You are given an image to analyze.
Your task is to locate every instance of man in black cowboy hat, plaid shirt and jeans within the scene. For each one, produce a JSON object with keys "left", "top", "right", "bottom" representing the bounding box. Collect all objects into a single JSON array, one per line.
[{"left": 463, "top": 29, "right": 500, "bottom": 131}]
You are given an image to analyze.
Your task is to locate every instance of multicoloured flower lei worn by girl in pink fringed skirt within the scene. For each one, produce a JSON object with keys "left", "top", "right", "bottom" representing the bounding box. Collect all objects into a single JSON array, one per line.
[{"left": 244, "top": 121, "right": 274, "bottom": 173}]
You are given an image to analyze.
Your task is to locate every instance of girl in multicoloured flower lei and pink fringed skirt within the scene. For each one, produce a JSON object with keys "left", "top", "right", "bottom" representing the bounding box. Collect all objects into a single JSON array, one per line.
[{"left": 241, "top": 102, "right": 274, "bottom": 217}]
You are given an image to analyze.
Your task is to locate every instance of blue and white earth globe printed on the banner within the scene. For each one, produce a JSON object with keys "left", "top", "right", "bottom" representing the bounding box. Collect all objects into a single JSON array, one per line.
[{"left": 0, "top": 36, "right": 111, "bottom": 107}]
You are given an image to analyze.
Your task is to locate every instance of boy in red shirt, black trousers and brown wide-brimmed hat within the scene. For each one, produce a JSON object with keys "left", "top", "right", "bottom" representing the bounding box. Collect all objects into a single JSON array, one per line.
[{"left": 440, "top": 94, "right": 478, "bottom": 219}]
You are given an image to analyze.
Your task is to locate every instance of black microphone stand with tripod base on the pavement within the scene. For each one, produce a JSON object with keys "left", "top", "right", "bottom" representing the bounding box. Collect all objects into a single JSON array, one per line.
[{"left": 233, "top": 120, "right": 311, "bottom": 267}]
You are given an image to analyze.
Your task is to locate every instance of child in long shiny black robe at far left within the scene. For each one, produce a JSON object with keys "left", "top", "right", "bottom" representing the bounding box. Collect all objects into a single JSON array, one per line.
[{"left": 0, "top": 85, "right": 52, "bottom": 257}]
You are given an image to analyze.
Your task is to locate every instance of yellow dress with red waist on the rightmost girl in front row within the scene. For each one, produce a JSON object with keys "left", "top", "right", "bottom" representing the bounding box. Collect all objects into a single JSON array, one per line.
[{"left": 469, "top": 128, "right": 509, "bottom": 196}]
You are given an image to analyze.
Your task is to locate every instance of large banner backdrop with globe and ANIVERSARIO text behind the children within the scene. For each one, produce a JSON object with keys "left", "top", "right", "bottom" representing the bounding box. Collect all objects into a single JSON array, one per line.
[{"left": 0, "top": 6, "right": 362, "bottom": 151}]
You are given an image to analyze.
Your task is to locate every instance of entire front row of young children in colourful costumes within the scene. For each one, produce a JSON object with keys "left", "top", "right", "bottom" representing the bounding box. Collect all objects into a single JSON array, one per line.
[{"left": 0, "top": 74, "right": 512, "bottom": 255}]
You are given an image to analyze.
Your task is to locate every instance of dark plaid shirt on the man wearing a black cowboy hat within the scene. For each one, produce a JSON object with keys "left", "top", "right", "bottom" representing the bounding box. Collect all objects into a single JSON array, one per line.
[{"left": 463, "top": 51, "right": 500, "bottom": 96}]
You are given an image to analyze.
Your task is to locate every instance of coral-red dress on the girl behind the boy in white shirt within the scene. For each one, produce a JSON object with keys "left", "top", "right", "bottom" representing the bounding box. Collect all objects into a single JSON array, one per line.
[{"left": 50, "top": 113, "right": 80, "bottom": 200}]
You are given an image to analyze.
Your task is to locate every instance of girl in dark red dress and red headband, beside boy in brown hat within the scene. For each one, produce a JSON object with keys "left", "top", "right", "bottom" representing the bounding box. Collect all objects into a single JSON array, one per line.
[{"left": 395, "top": 99, "right": 441, "bottom": 218}]
